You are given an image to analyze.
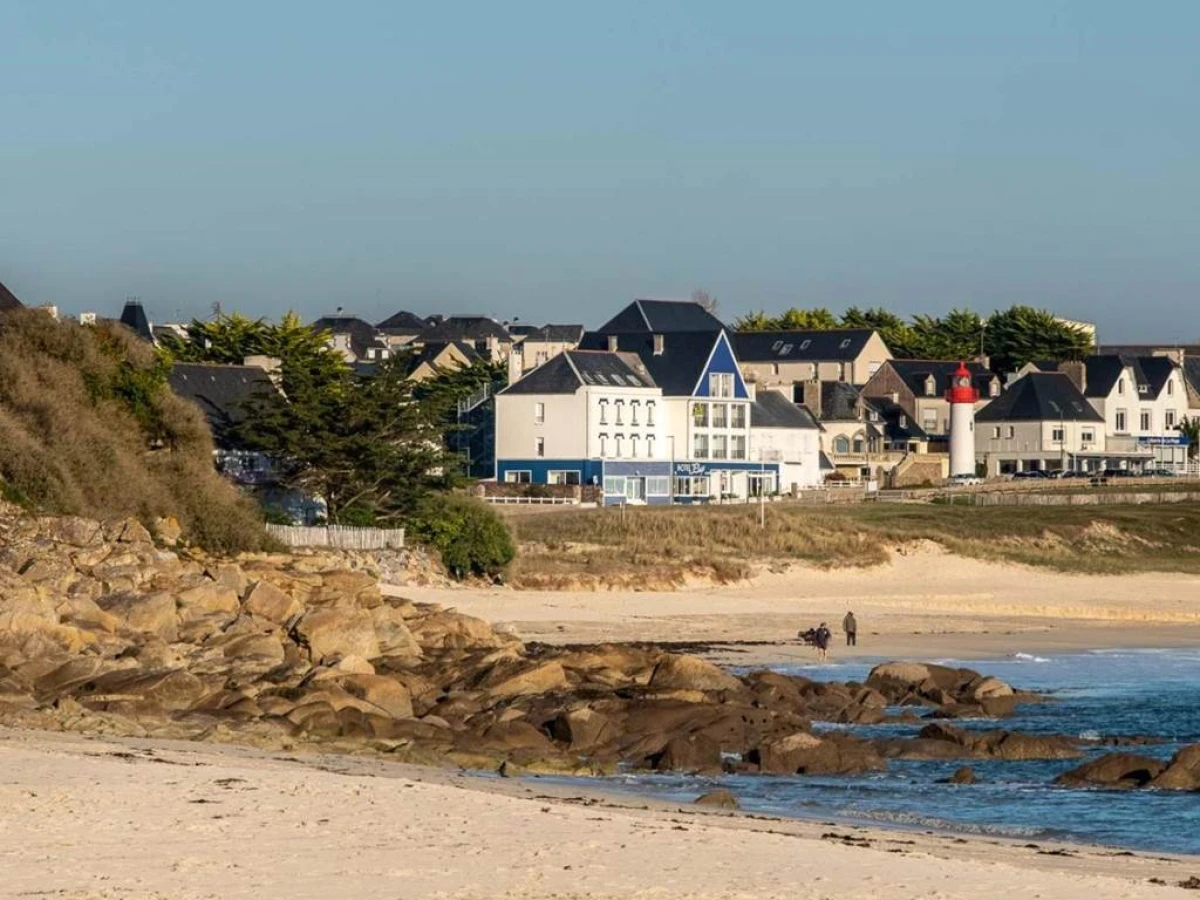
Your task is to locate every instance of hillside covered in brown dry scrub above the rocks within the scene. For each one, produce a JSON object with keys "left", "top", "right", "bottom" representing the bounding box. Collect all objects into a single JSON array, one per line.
[{"left": 0, "top": 310, "right": 263, "bottom": 551}]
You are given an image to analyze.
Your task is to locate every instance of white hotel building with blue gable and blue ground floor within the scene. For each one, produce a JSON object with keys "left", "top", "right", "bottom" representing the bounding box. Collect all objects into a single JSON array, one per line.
[{"left": 496, "top": 300, "right": 822, "bottom": 504}]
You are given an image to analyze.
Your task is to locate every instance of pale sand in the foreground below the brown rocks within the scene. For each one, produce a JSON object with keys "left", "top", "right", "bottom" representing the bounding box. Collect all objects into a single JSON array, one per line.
[{"left": 0, "top": 731, "right": 1200, "bottom": 900}]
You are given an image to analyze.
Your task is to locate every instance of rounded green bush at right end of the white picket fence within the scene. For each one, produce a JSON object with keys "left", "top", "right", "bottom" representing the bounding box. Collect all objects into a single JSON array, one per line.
[{"left": 412, "top": 494, "right": 516, "bottom": 578}]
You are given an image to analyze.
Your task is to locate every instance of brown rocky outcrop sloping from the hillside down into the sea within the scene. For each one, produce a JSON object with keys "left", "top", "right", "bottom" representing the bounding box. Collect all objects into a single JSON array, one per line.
[{"left": 0, "top": 518, "right": 1070, "bottom": 784}]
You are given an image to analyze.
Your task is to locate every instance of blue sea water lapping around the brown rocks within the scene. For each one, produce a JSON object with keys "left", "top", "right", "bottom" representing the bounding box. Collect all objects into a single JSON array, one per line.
[{"left": 588, "top": 649, "right": 1200, "bottom": 853}]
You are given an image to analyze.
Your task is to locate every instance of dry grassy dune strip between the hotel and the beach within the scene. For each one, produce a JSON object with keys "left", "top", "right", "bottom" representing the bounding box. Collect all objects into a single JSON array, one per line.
[{"left": 511, "top": 503, "right": 1200, "bottom": 589}]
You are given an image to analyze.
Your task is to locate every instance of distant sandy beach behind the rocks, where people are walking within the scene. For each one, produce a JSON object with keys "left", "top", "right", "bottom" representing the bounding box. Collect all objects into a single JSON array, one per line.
[{"left": 388, "top": 551, "right": 1200, "bottom": 665}]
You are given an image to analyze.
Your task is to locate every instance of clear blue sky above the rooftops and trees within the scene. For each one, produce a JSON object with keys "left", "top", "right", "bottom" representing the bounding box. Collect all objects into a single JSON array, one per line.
[{"left": 0, "top": 0, "right": 1200, "bottom": 340}]
